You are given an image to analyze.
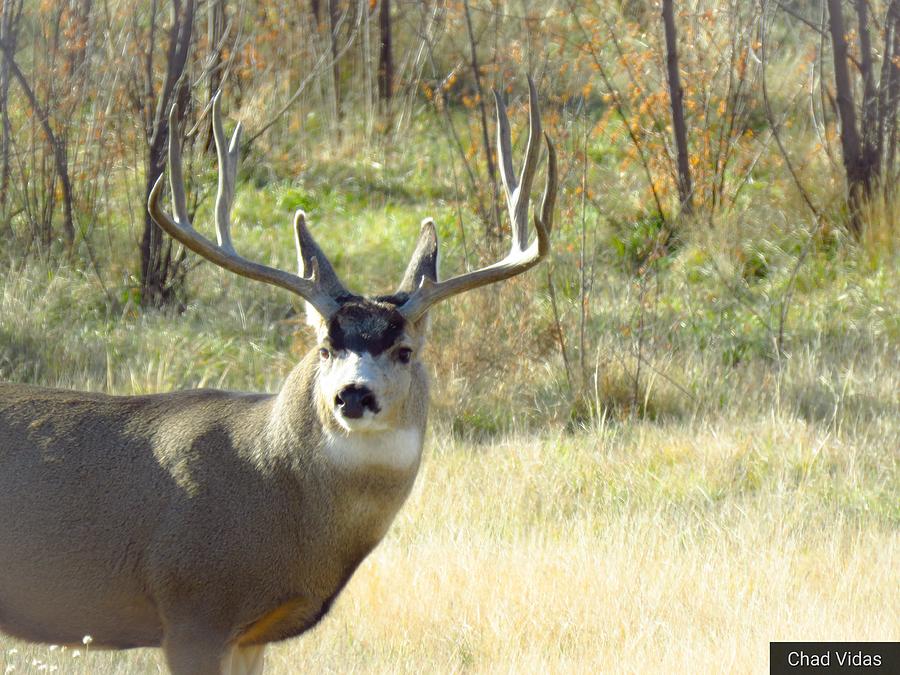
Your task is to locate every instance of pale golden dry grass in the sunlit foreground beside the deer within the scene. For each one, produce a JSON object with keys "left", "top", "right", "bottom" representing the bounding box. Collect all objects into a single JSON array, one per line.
[{"left": 0, "top": 416, "right": 900, "bottom": 673}]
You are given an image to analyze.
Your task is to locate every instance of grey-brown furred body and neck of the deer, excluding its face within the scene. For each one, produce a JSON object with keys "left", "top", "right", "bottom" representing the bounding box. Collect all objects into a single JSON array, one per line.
[{"left": 0, "top": 336, "right": 428, "bottom": 672}]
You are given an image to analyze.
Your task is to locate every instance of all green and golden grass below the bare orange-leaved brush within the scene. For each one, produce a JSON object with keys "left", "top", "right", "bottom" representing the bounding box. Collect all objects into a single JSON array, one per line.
[{"left": 0, "top": 62, "right": 900, "bottom": 673}]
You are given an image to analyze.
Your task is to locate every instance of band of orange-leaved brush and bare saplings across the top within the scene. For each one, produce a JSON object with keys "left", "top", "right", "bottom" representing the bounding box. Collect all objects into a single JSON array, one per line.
[{"left": 0, "top": 0, "right": 900, "bottom": 304}]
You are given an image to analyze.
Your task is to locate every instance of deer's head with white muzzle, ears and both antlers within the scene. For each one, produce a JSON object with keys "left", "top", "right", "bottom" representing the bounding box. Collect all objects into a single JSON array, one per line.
[{"left": 149, "top": 78, "right": 557, "bottom": 433}]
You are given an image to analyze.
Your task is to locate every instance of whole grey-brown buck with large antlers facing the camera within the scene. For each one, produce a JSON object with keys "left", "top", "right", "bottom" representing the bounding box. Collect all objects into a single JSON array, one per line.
[{"left": 0, "top": 78, "right": 558, "bottom": 675}]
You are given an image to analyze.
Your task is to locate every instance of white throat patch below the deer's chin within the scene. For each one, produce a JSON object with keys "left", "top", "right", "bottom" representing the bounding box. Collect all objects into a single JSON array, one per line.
[{"left": 324, "top": 428, "right": 422, "bottom": 471}]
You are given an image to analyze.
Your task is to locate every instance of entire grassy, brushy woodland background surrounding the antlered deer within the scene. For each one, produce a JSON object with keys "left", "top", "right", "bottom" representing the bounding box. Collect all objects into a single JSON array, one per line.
[{"left": 0, "top": 0, "right": 900, "bottom": 672}]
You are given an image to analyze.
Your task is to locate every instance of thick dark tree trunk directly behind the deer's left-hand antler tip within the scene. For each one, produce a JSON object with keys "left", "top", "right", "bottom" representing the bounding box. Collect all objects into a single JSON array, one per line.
[{"left": 140, "top": 0, "right": 195, "bottom": 307}]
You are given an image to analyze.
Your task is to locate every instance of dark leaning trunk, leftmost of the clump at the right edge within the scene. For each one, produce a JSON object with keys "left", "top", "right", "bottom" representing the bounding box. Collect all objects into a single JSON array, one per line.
[{"left": 828, "top": 0, "right": 869, "bottom": 236}]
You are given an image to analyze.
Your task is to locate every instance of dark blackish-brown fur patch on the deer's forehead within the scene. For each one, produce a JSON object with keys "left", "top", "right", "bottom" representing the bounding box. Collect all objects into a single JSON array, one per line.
[{"left": 328, "top": 299, "right": 406, "bottom": 356}]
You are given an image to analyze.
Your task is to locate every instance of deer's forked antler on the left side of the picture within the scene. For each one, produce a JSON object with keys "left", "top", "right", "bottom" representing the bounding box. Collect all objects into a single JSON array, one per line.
[{"left": 147, "top": 92, "right": 343, "bottom": 318}]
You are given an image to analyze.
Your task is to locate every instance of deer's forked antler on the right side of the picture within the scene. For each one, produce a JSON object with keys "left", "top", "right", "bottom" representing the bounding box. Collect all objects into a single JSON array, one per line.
[{"left": 399, "top": 77, "right": 557, "bottom": 321}]
